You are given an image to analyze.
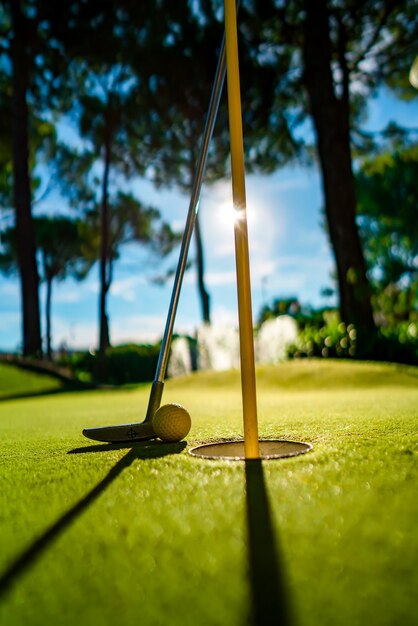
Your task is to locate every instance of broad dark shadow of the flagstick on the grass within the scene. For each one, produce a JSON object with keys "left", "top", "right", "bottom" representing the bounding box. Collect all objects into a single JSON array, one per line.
[{"left": 245, "top": 459, "right": 293, "bottom": 626}]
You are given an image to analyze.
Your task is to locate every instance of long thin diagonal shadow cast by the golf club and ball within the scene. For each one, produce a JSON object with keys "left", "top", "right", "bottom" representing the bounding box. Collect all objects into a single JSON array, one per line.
[{"left": 0, "top": 441, "right": 186, "bottom": 596}]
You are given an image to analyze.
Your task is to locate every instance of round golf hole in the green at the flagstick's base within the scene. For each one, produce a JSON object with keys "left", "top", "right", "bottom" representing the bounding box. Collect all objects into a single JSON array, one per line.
[{"left": 189, "top": 439, "right": 313, "bottom": 461}]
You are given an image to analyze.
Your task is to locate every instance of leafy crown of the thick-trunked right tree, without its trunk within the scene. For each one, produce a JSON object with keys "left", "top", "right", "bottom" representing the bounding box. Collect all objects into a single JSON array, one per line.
[{"left": 235, "top": 0, "right": 418, "bottom": 147}]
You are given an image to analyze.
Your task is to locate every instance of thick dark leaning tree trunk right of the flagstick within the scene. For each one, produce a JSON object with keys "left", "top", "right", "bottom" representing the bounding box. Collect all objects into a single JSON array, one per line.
[{"left": 304, "top": 0, "right": 376, "bottom": 342}]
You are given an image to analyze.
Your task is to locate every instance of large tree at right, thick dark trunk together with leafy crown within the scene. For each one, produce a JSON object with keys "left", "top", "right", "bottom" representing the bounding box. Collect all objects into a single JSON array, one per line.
[{"left": 238, "top": 0, "right": 418, "bottom": 335}]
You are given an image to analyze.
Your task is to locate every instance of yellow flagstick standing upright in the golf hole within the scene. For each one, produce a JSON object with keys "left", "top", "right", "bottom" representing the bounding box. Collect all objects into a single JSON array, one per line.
[{"left": 225, "top": 0, "right": 260, "bottom": 459}]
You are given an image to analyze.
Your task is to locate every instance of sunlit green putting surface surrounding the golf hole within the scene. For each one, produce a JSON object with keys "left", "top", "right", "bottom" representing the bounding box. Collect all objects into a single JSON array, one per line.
[{"left": 0, "top": 361, "right": 418, "bottom": 626}]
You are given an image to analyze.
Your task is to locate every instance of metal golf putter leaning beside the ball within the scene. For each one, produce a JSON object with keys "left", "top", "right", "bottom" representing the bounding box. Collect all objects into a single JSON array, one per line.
[{"left": 83, "top": 36, "right": 226, "bottom": 443}]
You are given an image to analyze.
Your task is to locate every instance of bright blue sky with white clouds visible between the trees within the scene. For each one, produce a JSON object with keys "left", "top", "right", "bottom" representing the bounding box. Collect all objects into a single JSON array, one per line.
[{"left": 0, "top": 92, "right": 418, "bottom": 351}]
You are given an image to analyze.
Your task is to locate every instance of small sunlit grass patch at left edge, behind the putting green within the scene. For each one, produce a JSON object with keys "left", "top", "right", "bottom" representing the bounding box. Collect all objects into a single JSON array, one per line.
[{"left": 0, "top": 363, "right": 62, "bottom": 400}]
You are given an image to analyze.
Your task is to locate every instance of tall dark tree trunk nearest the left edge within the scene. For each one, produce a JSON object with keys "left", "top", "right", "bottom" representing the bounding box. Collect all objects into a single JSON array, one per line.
[{"left": 10, "top": 0, "right": 42, "bottom": 356}]
